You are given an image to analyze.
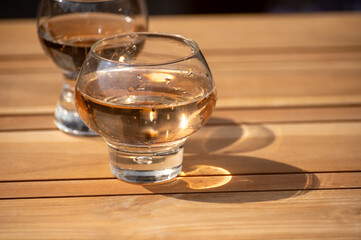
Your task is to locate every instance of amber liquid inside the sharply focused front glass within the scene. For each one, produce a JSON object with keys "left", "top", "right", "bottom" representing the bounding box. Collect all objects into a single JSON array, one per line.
[{"left": 76, "top": 69, "right": 216, "bottom": 145}]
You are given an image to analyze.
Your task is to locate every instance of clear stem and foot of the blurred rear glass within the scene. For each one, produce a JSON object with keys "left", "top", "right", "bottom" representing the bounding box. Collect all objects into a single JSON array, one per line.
[{"left": 54, "top": 79, "right": 97, "bottom": 136}]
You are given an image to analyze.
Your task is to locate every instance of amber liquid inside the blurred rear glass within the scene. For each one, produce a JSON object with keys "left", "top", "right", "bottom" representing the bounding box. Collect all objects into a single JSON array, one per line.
[{"left": 38, "top": 12, "right": 145, "bottom": 79}]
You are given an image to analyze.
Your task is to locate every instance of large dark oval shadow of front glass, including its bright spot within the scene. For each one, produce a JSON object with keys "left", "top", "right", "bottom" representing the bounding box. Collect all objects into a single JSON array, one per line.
[{"left": 143, "top": 155, "right": 319, "bottom": 203}]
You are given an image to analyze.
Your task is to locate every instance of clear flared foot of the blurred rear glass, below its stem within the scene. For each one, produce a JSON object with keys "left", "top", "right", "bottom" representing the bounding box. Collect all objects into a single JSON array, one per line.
[{"left": 54, "top": 104, "right": 98, "bottom": 136}]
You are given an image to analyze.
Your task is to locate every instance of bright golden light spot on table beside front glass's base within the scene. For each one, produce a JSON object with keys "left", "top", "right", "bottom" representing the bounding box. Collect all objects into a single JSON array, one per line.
[{"left": 179, "top": 165, "right": 232, "bottom": 189}]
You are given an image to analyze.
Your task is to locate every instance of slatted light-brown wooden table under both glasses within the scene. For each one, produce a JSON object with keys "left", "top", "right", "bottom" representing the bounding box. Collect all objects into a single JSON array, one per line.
[{"left": 0, "top": 13, "right": 361, "bottom": 239}]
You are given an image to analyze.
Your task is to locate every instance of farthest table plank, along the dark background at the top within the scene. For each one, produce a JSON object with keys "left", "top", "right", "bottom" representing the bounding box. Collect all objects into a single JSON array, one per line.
[{"left": 0, "top": 13, "right": 361, "bottom": 55}]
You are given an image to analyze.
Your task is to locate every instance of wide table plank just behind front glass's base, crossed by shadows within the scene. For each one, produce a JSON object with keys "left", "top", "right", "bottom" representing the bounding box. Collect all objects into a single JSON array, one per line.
[{"left": 0, "top": 122, "right": 361, "bottom": 181}]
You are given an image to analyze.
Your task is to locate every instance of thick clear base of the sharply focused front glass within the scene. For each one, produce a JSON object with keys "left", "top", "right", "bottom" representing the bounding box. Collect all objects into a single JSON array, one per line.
[{"left": 109, "top": 143, "right": 183, "bottom": 183}]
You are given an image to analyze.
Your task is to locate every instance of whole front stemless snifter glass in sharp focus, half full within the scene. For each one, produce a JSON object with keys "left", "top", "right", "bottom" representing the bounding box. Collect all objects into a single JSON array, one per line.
[{"left": 75, "top": 32, "right": 216, "bottom": 183}]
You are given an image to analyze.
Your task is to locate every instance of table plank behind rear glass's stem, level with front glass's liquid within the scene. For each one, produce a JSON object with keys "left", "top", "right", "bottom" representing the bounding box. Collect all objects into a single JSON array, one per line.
[{"left": 0, "top": 62, "right": 361, "bottom": 114}]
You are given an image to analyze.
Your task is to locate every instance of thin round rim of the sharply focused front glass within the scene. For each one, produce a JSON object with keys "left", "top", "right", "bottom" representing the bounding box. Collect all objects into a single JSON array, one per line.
[{"left": 89, "top": 32, "right": 200, "bottom": 67}]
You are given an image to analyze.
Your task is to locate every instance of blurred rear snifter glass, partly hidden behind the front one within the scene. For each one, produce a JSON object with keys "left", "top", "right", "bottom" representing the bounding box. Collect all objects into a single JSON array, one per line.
[{"left": 37, "top": 0, "right": 148, "bottom": 135}]
